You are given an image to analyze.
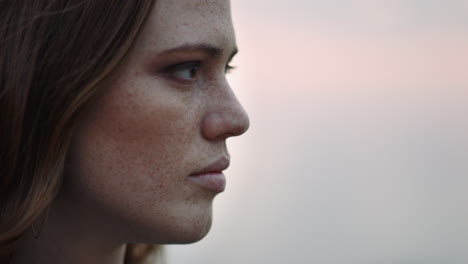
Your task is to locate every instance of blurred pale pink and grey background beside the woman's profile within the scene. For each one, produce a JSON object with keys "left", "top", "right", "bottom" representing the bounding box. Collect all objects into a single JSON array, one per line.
[{"left": 166, "top": 0, "right": 468, "bottom": 264}]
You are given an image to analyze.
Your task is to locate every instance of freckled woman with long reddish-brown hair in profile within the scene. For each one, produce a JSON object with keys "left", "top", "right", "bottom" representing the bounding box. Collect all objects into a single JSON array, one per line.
[{"left": 0, "top": 0, "right": 249, "bottom": 264}]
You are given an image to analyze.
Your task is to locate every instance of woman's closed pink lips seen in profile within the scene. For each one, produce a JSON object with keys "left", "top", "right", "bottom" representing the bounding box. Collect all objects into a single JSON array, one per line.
[{"left": 189, "top": 157, "right": 229, "bottom": 193}]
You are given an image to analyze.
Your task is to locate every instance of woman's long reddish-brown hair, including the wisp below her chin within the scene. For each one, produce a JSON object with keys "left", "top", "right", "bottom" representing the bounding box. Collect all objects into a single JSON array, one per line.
[{"left": 0, "top": 0, "right": 163, "bottom": 264}]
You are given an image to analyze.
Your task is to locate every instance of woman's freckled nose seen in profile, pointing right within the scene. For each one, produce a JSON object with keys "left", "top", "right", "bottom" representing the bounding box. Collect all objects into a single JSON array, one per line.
[{"left": 202, "top": 87, "right": 250, "bottom": 140}]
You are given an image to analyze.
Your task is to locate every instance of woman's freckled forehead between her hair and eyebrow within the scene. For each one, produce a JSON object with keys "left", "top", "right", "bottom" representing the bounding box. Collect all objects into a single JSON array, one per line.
[{"left": 139, "top": 0, "right": 235, "bottom": 51}]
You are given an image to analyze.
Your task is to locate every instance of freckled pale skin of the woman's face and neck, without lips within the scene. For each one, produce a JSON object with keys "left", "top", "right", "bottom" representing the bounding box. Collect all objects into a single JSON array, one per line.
[{"left": 13, "top": 0, "right": 249, "bottom": 264}]
